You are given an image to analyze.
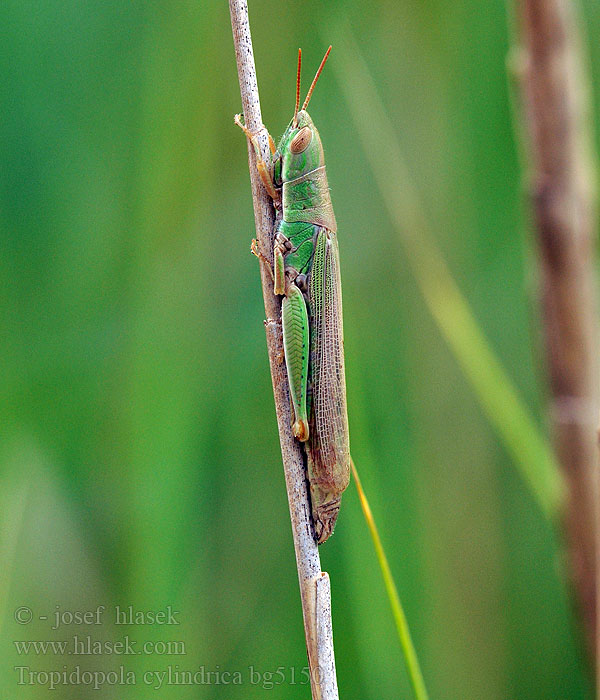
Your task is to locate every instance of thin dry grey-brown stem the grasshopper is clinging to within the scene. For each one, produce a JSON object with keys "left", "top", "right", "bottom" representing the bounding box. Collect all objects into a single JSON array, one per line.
[{"left": 229, "top": 0, "right": 338, "bottom": 700}]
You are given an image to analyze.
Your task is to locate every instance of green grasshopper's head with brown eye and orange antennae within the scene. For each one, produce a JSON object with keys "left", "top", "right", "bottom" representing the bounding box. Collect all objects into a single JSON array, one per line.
[{"left": 274, "top": 46, "right": 331, "bottom": 183}]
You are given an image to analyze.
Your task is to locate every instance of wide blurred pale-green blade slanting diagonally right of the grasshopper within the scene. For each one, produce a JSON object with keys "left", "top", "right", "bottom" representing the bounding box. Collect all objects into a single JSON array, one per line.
[{"left": 328, "top": 25, "right": 564, "bottom": 521}]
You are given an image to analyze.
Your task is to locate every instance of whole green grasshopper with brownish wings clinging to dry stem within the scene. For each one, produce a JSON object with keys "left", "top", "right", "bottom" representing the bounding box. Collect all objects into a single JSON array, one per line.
[{"left": 235, "top": 46, "right": 350, "bottom": 544}]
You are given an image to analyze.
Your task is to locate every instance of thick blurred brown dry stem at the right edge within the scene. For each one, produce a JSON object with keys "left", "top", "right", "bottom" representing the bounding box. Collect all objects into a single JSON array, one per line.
[{"left": 517, "top": 0, "right": 599, "bottom": 658}]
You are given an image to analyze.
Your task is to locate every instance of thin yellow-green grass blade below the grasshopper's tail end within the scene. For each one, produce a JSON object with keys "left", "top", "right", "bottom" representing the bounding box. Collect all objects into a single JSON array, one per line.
[{"left": 350, "top": 458, "right": 429, "bottom": 700}]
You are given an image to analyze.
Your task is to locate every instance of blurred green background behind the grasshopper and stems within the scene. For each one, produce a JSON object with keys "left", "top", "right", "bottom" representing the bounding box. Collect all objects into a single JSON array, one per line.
[{"left": 0, "top": 0, "right": 600, "bottom": 700}]
